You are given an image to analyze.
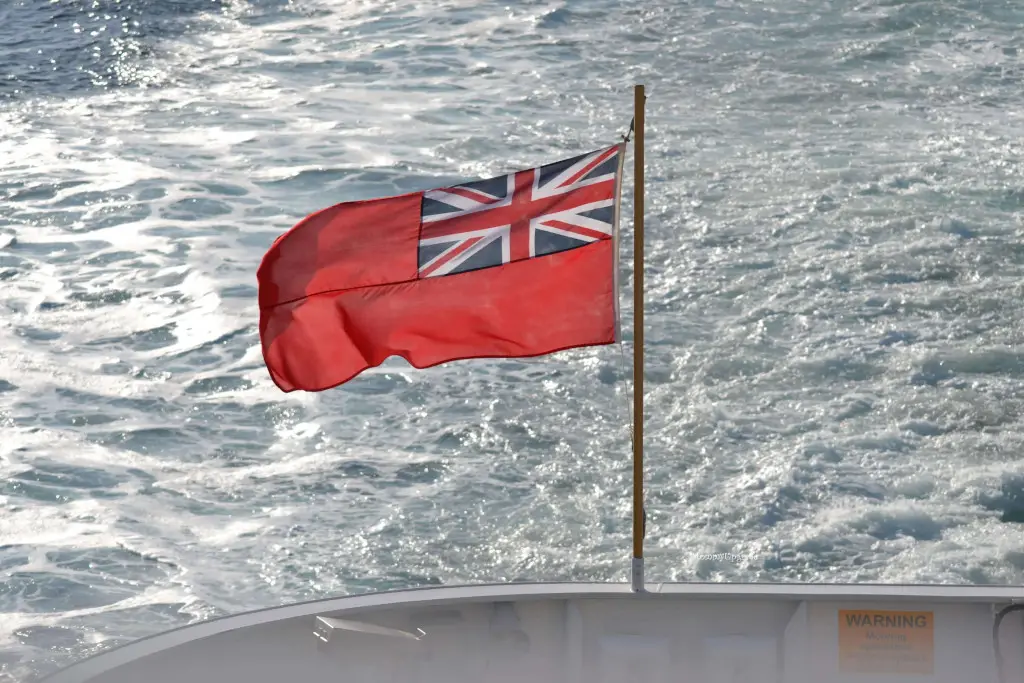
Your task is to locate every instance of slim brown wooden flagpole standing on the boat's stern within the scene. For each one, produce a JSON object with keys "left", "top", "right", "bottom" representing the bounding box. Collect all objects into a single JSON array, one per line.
[{"left": 632, "top": 84, "right": 647, "bottom": 593}]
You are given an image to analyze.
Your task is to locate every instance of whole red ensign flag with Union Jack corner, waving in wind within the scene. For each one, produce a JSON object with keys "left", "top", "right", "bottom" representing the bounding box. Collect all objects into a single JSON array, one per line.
[{"left": 257, "top": 143, "right": 625, "bottom": 391}]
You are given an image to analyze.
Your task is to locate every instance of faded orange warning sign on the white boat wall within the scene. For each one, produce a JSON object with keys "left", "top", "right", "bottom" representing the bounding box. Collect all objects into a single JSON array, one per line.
[{"left": 839, "top": 609, "right": 935, "bottom": 674}]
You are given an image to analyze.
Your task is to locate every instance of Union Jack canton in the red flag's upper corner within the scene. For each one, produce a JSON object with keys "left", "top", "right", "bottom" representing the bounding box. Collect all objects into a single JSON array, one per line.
[{"left": 419, "top": 144, "right": 624, "bottom": 278}]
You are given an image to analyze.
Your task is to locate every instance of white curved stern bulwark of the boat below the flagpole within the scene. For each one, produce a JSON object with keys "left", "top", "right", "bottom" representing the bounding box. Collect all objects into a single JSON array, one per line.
[{"left": 37, "top": 584, "right": 1024, "bottom": 683}]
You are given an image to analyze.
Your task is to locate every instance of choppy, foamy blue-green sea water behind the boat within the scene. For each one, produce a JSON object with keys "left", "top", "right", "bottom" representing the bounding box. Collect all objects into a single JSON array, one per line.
[{"left": 0, "top": 0, "right": 1024, "bottom": 681}]
